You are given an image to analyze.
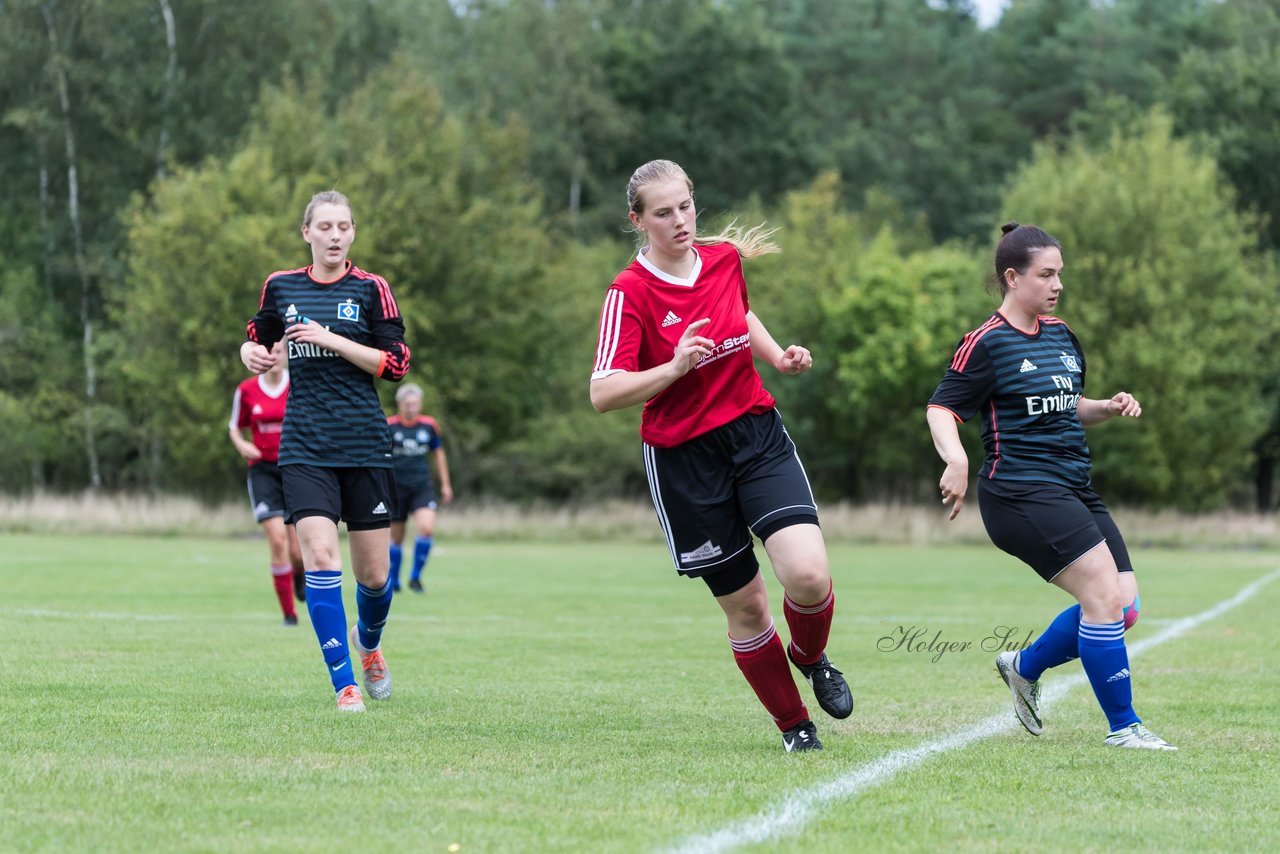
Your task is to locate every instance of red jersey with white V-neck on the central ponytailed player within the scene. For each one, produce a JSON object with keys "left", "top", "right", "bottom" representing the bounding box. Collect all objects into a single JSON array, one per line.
[{"left": 591, "top": 243, "right": 773, "bottom": 448}]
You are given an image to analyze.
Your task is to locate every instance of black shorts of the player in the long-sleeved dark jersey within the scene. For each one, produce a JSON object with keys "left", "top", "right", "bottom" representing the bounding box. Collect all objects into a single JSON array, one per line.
[{"left": 280, "top": 463, "right": 396, "bottom": 531}]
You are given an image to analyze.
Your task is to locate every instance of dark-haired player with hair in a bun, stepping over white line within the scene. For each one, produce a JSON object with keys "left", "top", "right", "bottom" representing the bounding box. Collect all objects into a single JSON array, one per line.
[{"left": 928, "top": 223, "right": 1175, "bottom": 750}]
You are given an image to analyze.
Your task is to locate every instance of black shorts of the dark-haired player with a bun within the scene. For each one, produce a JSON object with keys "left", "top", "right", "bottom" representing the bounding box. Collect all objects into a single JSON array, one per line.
[{"left": 978, "top": 478, "right": 1133, "bottom": 581}]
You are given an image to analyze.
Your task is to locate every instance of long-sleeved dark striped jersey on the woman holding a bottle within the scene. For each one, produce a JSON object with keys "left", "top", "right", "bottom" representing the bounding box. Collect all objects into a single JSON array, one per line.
[{"left": 248, "top": 261, "right": 410, "bottom": 469}]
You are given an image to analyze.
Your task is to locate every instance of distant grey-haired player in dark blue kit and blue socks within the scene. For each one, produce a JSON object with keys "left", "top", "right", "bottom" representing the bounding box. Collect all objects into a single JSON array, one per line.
[{"left": 387, "top": 383, "right": 453, "bottom": 593}]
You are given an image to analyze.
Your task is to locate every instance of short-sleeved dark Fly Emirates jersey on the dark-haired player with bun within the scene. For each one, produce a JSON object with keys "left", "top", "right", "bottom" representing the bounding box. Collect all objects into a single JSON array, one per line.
[{"left": 929, "top": 311, "right": 1091, "bottom": 487}]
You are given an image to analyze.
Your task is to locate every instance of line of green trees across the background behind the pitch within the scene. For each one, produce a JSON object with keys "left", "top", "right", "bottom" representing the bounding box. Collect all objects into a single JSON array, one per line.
[{"left": 0, "top": 0, "right": 1280, "bottom": 510}]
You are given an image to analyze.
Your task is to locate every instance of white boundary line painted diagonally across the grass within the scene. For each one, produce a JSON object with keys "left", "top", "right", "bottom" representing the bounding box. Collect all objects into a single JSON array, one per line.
[{"left": 668, "top": 570, "right": 1280, "bottom": 854}]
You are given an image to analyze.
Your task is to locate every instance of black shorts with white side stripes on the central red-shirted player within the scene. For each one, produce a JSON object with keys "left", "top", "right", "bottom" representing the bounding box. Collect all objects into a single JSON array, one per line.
[{"left": 644, "top": 410, "right": 818, "bottom": 580}]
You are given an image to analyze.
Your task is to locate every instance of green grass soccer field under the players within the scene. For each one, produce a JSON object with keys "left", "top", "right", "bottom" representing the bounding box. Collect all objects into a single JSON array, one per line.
[{"left": 0, "top": 535, "right": 1280, "bottom": 851}]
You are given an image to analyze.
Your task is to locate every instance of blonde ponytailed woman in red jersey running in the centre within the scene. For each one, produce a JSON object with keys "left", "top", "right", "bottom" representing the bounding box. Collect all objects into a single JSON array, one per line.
[{"left": 591, "top": 160, "right": 852, "bottom": 752}]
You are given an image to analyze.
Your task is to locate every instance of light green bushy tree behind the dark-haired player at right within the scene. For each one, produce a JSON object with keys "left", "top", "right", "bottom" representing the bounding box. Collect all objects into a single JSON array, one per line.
[{"left": 1004, "top": 111, "right": 1277, "bottom": 510}]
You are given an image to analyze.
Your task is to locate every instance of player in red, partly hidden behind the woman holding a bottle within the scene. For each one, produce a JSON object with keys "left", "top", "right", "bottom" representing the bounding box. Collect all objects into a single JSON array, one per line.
[{"left": 228, "top": 342, "right": 306, "bottom": 626}]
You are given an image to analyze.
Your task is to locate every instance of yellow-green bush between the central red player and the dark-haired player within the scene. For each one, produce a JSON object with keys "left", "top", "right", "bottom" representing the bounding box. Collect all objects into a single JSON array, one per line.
[{"left": 748, "top": 175, "right": 991, "bottom": 498}]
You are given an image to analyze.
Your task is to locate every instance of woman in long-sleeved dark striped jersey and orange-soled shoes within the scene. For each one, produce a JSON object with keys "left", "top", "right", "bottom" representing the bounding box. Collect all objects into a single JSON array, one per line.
[{"left": 241, "top": 192, "right": 410, "bottom": 712}]
